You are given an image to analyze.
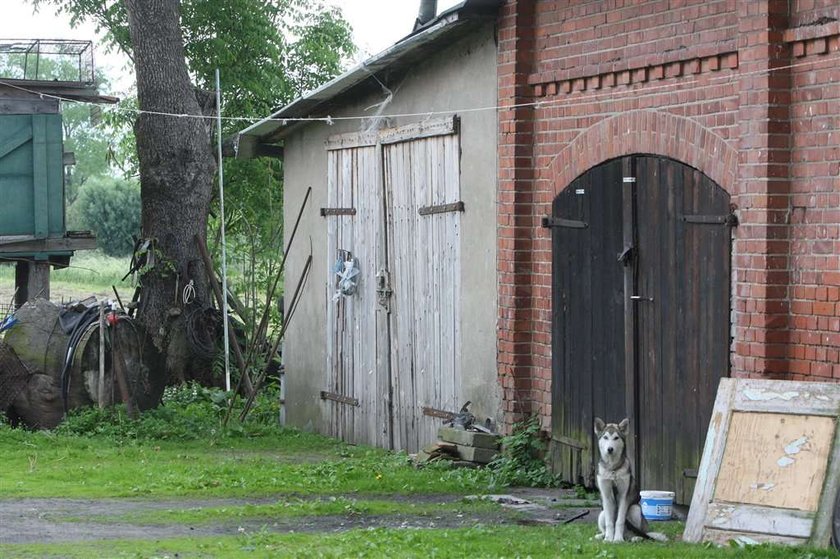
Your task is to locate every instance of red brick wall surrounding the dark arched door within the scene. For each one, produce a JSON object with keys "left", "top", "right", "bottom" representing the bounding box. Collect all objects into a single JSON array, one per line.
[{"left": 498, "top": 0, "right": 840, "bottom": 426}]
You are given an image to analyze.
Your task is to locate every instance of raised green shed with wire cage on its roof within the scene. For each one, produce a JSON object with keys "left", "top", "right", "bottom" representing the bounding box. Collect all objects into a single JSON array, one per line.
[{"left": 0, "top": 40, "right": 117, "bottom": 306}]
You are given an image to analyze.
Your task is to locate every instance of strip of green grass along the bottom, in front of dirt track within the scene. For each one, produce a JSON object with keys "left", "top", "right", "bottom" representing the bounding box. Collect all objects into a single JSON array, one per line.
[{"left": 0, "top": 525, "right": 837, "bottom": 559}]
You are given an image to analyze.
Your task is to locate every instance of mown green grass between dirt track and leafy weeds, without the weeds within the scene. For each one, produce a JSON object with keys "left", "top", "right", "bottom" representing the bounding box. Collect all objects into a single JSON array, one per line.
[{"left": 0, "top": 428, "right": 486, "bottom": 498}]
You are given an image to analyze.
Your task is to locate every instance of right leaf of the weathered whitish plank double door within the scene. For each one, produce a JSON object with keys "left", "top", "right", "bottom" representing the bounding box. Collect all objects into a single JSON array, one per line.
[{"left": 383, "top": 119, "right": 464, "bottom": 451}]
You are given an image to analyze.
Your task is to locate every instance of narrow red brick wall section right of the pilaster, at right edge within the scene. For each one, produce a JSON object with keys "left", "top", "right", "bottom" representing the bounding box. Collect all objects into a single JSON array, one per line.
[{"left": 786, "top": 24, "right": 840, "bottom": 380}]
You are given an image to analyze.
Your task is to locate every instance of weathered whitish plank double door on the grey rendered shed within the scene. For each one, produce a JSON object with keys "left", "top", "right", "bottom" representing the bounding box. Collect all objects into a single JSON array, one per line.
[{"left": 321, "top": 118, "right": 463, "bottom": 451}]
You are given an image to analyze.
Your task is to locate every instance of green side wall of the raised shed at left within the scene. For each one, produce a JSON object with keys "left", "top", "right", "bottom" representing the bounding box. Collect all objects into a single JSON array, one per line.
[{"left": 0, "top": 114, "right": 64, "bottom": 239}]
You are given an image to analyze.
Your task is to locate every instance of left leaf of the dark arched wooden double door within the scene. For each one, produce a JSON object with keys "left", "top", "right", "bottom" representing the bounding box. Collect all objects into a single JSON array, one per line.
[{"left": 551, "top": 156, "right": 626, "bottom": 485}]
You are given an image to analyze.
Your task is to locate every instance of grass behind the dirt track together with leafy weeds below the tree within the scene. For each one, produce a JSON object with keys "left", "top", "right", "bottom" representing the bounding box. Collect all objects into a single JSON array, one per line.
[{"left": 0, "top": 385, "right": 488, "bottom": 498}]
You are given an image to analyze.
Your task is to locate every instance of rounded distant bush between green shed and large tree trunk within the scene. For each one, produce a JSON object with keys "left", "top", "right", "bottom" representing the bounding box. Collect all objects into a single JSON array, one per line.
[{"left": 67, "top": 176, "right": 141, "bottom": 256}]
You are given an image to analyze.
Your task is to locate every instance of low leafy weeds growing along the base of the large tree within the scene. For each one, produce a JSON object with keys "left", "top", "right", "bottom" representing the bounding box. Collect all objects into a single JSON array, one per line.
[{"left": 57, "top": 383, "right": 280, "bottom": 441}]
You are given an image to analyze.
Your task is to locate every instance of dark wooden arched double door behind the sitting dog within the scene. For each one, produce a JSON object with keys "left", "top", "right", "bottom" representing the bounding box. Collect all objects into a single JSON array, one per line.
[{"left": 547, "top": 155, "right": 735, "bottom": 503}]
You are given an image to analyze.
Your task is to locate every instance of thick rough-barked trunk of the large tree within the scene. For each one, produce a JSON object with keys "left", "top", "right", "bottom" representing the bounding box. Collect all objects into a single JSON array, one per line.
[{"left": 125, "top": 0, "right": 215, "bottom": 376}]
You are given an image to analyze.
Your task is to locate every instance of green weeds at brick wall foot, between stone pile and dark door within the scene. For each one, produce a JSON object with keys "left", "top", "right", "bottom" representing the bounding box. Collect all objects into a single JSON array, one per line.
[{"left": 482, "top": 416, "right": 560, "bottom": 487}]
